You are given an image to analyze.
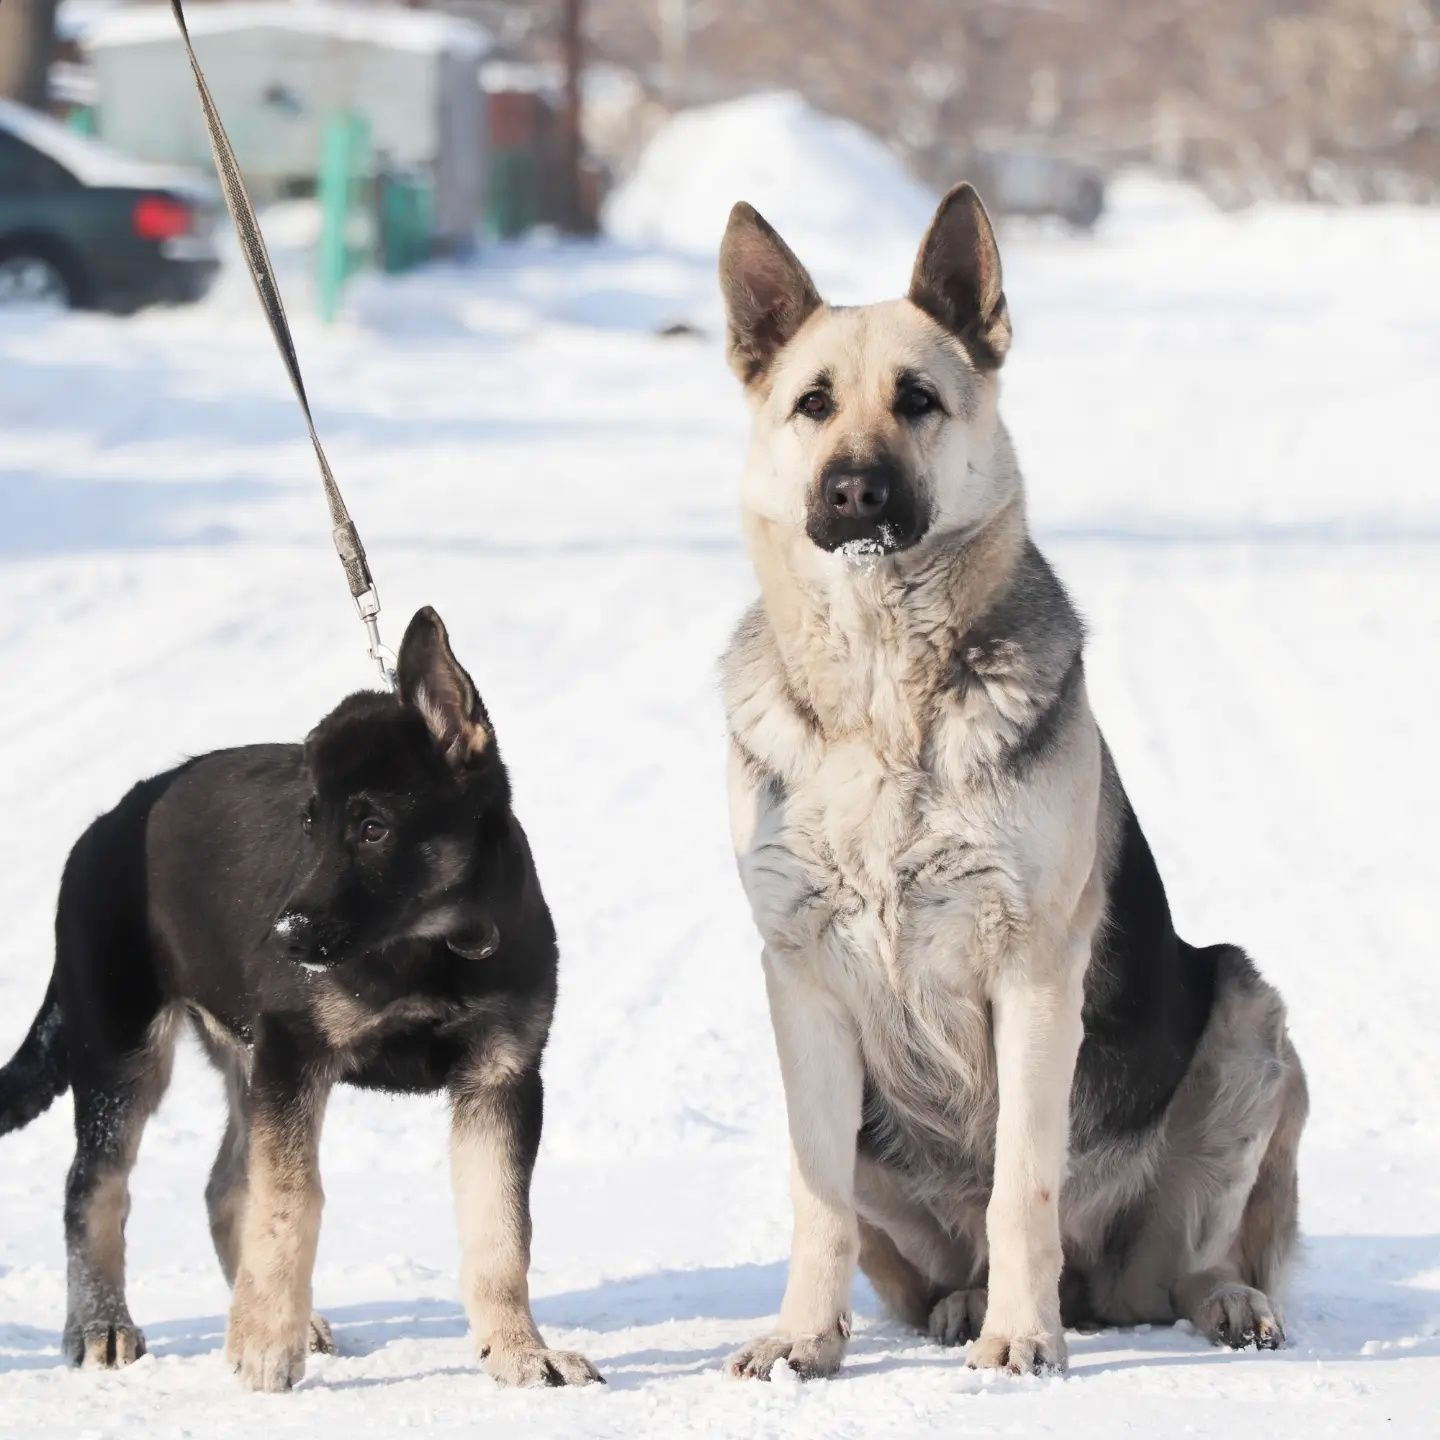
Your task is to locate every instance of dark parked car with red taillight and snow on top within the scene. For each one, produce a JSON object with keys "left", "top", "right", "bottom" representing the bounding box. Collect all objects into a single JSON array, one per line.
[{"left": 0, "top": 101, "right": 219, "bottom": 312}]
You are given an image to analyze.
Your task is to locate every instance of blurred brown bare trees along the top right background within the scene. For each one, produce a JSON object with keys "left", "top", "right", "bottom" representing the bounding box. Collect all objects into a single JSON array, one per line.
[{"left": 446, "top": 0, "right": 1440, "bottom": 200}]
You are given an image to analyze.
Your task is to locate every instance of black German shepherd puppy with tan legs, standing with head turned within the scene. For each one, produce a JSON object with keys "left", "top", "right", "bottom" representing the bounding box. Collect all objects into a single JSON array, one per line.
[{"left": 0, "top": 609, "right": 599, "bottom": 1390}]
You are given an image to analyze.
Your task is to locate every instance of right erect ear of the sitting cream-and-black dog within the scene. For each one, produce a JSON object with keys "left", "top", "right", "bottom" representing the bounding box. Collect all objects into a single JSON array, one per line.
[{"left": 910, "top": 184, "right": 1009, "bottom": 370}]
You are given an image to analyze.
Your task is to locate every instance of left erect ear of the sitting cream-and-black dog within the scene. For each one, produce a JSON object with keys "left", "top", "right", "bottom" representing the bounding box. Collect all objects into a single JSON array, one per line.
[{"left": 720, "top": 200, "right": 821, "bottom": 384}]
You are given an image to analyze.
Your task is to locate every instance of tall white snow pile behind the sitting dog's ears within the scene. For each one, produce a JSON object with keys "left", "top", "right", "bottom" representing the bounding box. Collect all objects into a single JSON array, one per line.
[{"left": 605, "top": 92, "right": 936, "bottom": 298}]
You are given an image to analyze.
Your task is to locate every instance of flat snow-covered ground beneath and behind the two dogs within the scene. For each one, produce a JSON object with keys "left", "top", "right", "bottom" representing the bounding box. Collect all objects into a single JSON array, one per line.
[{"left": 0, "top": 98, "right": 1440, "bottom": 1440}]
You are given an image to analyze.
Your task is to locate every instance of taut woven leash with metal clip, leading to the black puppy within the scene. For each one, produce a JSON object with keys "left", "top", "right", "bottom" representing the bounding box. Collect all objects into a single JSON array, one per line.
[{"left": 170, "top": 0, "right": 396, "bottom": 690}]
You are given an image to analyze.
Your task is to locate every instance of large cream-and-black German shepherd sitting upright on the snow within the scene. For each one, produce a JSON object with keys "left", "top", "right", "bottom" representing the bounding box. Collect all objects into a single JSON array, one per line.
[{"left": 720, "top": 186, "right": 1308, "bottom": 1377}]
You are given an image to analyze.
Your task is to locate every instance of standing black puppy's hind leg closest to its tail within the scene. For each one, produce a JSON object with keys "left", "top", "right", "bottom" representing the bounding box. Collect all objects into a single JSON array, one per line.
[{"left": 63, "top": 1011, "right": 174, "bottom": 1369}]
